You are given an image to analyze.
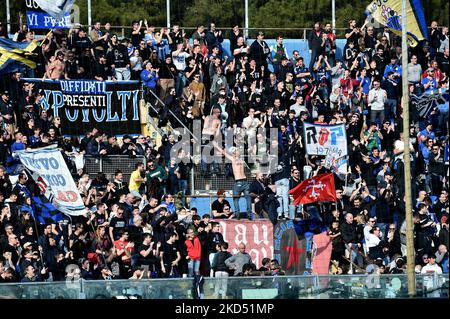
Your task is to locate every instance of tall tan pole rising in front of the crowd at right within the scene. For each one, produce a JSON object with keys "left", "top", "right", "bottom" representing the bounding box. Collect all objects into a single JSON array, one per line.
[{"left": 402, "top": 0, "right": 416, "bottom": 297}]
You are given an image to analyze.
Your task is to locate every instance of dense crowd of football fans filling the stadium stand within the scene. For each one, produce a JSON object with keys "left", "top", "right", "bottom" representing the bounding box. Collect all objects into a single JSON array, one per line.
[{"left": 0, "top": 15, "right": 449, "bottom": 284}]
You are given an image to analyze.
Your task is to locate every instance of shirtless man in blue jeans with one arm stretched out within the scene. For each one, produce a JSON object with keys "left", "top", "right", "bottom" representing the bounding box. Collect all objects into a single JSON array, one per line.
[{"left": 214, "top": 143, "right": 252, "bottom": 220}]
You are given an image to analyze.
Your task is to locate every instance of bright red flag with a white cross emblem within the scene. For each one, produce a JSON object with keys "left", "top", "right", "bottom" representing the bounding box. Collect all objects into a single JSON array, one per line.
[{"left": 289, "top": 173, "right": 336, "bottom": 205}]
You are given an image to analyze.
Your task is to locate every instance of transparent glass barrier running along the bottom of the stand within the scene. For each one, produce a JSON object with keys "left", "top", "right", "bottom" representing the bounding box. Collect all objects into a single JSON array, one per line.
[{"left": 0, "top": 274, "right": 449, "bottom": 299}]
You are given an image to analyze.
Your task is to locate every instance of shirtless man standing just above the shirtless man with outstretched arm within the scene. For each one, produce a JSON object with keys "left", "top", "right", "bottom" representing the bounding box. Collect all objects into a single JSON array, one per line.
[{"left": 201, "top": 108, "right": 222, "bottom": 176}]
